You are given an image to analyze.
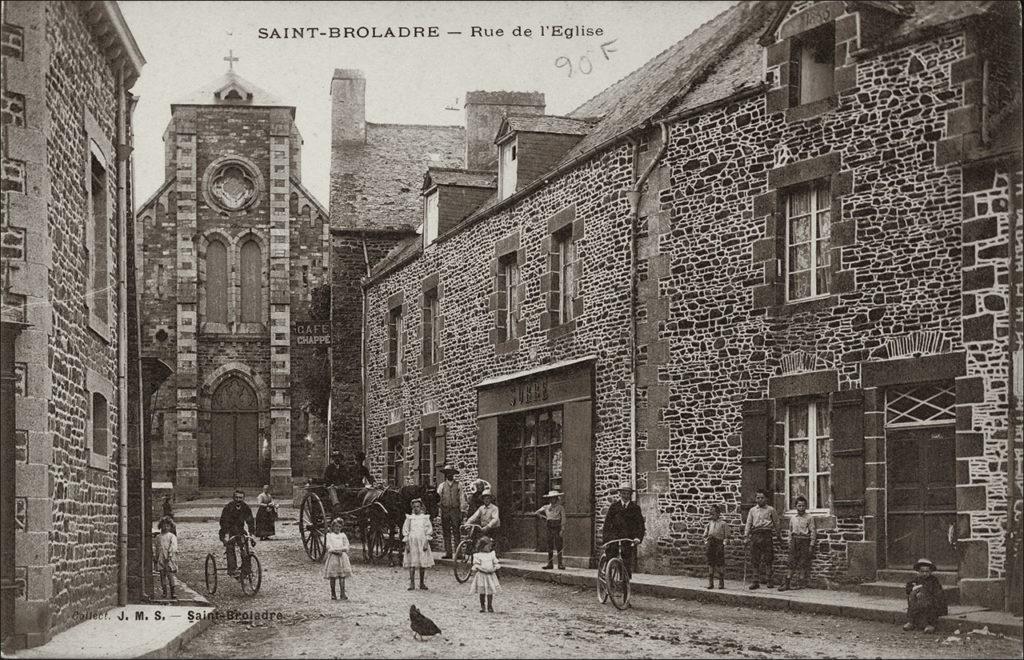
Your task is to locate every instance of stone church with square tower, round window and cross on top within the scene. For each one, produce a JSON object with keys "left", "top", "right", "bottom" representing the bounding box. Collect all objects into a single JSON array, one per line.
[{"left": 136, "top": 61, "right": 330, "bottom": 496}]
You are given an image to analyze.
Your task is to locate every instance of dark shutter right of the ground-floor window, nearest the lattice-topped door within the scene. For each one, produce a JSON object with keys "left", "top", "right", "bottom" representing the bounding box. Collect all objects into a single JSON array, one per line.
[{"left": 830, "top": 390, "right": 864, "bottom": 518}]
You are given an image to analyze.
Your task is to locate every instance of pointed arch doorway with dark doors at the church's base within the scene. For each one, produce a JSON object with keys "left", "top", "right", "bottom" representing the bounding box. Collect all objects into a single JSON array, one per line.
[{"left": 202, "top": 376, "right": 265, "bottom": 487}]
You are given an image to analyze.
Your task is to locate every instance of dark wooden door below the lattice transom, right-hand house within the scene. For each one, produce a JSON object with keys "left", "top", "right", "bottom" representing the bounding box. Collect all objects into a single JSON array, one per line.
[{"left": 886, "top": 426, "right": 958, "bottom": 571}]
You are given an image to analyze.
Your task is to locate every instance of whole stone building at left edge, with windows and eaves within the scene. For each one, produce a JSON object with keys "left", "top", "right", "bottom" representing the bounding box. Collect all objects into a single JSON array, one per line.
[{"left": 0, "top": 2, "right": 152, "bottom": 653}]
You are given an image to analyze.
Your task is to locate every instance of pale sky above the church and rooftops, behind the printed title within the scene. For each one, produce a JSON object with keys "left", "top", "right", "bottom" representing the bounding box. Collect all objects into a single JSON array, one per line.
[{"left": 120, "top": 0, "right": 733, "bottom": 207}]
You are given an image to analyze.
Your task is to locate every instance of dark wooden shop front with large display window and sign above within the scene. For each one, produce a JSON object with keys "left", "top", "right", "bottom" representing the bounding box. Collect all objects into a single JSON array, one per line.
[{"left": 477, "top": 357, "right": 596, "bottom": 565}]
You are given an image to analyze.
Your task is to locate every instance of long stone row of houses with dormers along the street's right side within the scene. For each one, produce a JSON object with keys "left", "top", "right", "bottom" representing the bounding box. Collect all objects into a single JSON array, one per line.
[{"left": 332, "top": 2, "right": 1021, "bottom": 606}]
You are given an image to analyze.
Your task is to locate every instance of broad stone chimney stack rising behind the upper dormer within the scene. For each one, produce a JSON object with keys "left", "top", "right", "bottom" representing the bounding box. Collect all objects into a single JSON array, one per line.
[{"left": 464, "top": 91, "right": 544, "bottom": 170}]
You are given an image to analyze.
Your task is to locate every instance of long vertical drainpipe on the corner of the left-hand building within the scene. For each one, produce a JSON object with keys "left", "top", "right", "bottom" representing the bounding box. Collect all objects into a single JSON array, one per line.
[{"left": 117, "top": 65, "right": 128, "bottom": 606}]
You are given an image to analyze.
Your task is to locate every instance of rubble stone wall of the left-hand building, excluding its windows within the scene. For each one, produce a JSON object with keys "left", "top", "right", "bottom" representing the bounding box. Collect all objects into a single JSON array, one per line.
[{"left": 3, "top": 2, "right": 131, "bottom": 646}]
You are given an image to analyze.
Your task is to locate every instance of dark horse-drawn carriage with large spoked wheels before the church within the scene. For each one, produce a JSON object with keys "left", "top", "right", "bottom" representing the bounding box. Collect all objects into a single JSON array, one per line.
[{"left": 299, "top": 480, "right": 438, "bottom": 563}]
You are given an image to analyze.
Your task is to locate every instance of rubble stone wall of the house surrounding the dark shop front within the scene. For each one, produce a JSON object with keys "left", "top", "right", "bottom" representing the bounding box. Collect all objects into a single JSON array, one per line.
[{"left": 365, "top": 145, "right": 633, "bottom": 540}]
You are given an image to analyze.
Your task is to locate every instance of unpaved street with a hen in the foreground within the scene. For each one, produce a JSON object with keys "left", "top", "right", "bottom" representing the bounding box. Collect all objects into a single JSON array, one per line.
[{"left": 172, "top": 521, "right": 1021, "bottom": 658}]
